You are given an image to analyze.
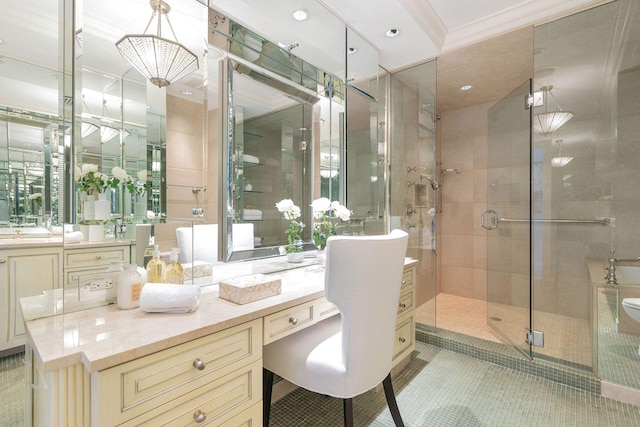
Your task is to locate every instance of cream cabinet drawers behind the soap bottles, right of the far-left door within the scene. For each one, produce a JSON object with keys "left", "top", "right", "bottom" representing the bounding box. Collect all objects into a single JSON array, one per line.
[{"left": 64, "top": 240, "right": 131, "bottom": 289}]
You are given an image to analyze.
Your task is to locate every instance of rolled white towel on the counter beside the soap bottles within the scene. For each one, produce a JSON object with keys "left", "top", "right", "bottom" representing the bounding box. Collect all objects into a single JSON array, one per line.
[{"left": 140, "top": 283, "right": 200, "bottom": 313}]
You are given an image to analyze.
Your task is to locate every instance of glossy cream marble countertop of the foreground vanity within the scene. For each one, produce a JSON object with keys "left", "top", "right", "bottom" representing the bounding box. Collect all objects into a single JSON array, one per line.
[{"left": 21, "top": 257, "right": 417, "bottom": 373}]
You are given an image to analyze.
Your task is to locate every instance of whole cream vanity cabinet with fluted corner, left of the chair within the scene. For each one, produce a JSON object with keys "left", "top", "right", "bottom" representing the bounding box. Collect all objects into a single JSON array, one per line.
[{"left": 33, "top": 319, "right": 262, "bottom": 427}]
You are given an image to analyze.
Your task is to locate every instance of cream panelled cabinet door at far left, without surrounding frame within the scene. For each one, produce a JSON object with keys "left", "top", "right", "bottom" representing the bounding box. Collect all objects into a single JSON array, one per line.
[{"left": 6, "top": 252, "right": 60, "bottom": 345}]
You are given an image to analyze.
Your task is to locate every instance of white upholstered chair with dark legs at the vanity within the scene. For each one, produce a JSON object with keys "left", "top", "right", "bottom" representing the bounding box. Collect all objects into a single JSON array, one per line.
[{"left": 263, "top": 230, "right": 408, "bottom": 426}]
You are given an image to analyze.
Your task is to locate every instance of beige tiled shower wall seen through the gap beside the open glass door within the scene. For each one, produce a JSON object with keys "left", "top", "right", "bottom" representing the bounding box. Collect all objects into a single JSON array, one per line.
[{"left": 438, "top": 103, "right": 493, "bottom": 300}]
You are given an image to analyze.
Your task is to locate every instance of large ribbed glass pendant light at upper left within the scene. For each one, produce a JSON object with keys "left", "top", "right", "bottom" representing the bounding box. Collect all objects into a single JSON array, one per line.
[{"left": 116, "top": 0, "right": 198, "bottom": 87}]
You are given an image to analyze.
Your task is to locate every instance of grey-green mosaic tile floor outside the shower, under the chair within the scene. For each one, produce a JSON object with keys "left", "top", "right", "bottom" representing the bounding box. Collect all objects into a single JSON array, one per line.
[{"left": 270, "top": 342, "right": 640, "bottom": 427}]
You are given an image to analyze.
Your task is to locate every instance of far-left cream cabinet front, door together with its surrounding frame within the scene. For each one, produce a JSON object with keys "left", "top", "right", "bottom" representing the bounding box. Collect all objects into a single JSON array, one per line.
[{"left": 0, "top": 245, "right": 62, "bottom": 351}]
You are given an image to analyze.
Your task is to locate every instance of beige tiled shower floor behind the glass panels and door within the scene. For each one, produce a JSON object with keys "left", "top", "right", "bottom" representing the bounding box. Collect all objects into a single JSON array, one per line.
[{"left": 416, "top": 293, "right": 592, "bottom": 370}]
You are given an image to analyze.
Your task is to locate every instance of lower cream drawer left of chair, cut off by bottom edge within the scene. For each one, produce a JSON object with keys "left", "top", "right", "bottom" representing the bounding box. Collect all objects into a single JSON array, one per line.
[{"left": 122, "top": 361, "right": 262, "bottom": 427}]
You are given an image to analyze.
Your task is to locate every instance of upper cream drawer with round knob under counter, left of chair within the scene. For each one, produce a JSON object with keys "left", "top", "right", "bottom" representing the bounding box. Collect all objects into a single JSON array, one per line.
[{"left": 92, "top": 319, "right": 262, "bottom": 425}]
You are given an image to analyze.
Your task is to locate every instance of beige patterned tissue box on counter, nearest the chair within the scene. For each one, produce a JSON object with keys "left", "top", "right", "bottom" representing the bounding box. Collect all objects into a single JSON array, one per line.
[{"left": 219, "top": 274, "right": 281, "bottom": 304}]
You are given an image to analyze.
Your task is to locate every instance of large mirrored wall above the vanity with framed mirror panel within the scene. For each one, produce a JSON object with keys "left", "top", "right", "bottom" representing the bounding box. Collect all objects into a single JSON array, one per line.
[{"left": 0, "top": 0, "right": 379, "bottom": 320}]
